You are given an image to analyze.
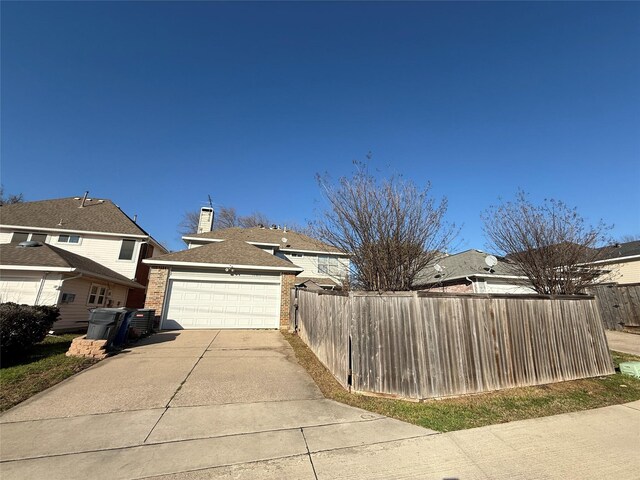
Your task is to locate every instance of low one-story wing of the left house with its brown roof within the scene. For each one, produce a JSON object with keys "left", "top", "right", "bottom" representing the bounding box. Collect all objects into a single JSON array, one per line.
[{"left": 0, "top": 241, "right": 142, "bottom": 331}]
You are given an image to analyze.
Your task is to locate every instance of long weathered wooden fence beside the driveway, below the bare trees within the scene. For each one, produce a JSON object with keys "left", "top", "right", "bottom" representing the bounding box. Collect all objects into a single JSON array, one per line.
[{"left": 292, "top": 290, "right": 614, "bottom": 400}]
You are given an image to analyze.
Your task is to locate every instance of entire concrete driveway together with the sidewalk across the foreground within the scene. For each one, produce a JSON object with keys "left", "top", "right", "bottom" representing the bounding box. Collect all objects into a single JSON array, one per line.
[{"left": 0, "top": 330, "right": 640, "bottom": 480}]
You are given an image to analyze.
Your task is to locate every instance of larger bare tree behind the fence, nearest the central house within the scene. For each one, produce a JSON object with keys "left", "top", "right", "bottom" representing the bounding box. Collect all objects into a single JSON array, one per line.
[{"left": 314, "top": 162, "right": 455, "bottom": 291}]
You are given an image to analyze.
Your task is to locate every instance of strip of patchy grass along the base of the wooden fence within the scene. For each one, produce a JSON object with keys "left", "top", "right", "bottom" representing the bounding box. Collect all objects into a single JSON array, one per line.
[{"left": 283, "top": 332, "right": 640, "bottom": 432}]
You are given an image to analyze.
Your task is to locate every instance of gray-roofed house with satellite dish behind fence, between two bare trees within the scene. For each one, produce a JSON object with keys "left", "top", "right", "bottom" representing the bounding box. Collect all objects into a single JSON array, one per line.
[{"left": 413, "top": 250, "right": 535, "bottom": 294}]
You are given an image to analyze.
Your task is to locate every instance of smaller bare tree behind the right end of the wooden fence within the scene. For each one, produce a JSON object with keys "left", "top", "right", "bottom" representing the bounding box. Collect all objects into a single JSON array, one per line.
[{"left": 482, "top": 190, "right": 611, "bottom": 295}]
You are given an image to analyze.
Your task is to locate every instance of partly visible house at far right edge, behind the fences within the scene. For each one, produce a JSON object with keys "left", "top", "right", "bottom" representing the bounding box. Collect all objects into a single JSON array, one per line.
[{"left": 594, "top": 240, "right": 640, "bottom": 285}]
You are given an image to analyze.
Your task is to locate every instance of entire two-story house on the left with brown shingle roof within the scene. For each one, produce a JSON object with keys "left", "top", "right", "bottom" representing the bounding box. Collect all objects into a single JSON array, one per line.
[{"left": 0, "top": 194, "right": 167, "bottom": 330}]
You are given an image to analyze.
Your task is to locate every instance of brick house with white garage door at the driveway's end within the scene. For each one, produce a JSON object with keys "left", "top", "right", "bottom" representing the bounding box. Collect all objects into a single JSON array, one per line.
[{"left": 144, "top": 219, "right": 349, "bottom": 329}]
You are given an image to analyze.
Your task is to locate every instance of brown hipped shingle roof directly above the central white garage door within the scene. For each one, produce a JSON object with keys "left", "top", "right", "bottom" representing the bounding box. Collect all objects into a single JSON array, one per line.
[{"left": 145, "top": 240, "right": 302, "bottom": 271}]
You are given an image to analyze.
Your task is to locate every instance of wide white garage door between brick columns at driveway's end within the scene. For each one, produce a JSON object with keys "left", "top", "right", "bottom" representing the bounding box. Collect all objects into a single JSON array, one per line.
[{"left": 162, "top": 279, "right": 280, "bottom": 329}]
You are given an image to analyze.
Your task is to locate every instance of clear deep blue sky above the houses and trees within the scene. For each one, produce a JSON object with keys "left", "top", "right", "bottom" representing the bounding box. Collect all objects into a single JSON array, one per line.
[{"left": 1, "top": 2, "right": 640, "bottom": 249}]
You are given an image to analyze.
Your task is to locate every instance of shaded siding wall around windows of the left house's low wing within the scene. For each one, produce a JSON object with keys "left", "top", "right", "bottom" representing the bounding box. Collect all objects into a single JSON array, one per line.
[{"left": 54, "top": 277, "right": 129, "bottom": 330}]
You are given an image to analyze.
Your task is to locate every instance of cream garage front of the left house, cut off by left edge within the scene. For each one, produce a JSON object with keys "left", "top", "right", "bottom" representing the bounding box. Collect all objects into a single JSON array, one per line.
[{"left": 0, "top": 270, "right": 60, "bottom": 305}]
